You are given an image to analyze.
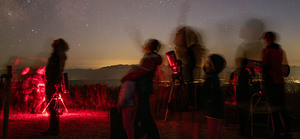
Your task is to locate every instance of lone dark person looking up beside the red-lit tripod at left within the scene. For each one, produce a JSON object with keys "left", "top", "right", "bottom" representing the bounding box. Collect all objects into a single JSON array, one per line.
[{"left": 43, "top": 39, "right": 69, "bottom": 136}]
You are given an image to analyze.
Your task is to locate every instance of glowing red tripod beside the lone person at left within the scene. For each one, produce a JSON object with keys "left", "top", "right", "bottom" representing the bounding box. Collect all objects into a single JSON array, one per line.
[{"left": 42, "top": 85, "right": 69, "bottom": 115}]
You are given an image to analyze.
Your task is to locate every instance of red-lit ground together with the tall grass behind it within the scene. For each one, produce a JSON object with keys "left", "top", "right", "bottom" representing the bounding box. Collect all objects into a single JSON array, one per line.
[{"left": 0, "top": 84, "right": 300, "bottom": 139}]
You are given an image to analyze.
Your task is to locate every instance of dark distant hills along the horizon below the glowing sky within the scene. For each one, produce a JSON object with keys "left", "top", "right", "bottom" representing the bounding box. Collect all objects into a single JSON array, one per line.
[{"left": 0, "top": 65, "right": 300, "bottom": 86}]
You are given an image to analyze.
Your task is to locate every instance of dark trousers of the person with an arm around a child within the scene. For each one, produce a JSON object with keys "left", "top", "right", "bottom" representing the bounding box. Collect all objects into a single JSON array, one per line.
[{"left": 135, "top": 92, "right": 160, "bottom": 139}]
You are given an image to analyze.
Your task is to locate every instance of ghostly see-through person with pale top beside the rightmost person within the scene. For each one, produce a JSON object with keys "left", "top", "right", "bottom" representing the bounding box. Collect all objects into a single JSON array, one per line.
[{"left": 233, "top": 18, "right": 265, "bottom": 135}]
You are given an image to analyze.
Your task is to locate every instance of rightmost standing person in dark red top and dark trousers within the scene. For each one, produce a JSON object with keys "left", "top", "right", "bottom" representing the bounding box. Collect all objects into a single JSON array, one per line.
[{"left": 262, "top": 32, "right": 289, "bottom": 138}]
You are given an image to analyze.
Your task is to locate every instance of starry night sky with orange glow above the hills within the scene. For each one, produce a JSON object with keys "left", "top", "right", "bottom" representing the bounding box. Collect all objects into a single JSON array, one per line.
[{"left": 0, "top": 0, "right": 300, "bottom": 69}]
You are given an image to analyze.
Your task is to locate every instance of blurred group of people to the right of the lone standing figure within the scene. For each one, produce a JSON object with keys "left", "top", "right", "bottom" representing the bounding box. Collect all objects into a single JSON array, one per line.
[{"left": 115, "top": 22, "right": 289, "bottom": 139}]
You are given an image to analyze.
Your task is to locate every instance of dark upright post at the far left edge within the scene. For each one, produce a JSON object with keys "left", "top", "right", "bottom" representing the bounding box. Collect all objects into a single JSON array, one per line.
[{"left": 2, "top": 66, "right": 12, "bottom": 139}]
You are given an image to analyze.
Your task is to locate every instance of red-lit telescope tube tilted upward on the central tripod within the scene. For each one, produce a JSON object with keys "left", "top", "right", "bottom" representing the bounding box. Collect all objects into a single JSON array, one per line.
[{"left": 166, "top": 51, "right": 182, "bottom": 80}]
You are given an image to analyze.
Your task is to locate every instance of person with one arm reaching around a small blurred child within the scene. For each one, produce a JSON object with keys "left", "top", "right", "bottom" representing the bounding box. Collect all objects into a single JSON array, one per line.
[{"left": 121, "top": 39, "right": 162, "bottom": 139}]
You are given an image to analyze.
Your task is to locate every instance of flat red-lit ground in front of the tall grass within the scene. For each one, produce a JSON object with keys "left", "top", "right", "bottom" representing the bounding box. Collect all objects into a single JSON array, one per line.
[{"left": 0, "top": 110, "right": 300, "bottom": 139}]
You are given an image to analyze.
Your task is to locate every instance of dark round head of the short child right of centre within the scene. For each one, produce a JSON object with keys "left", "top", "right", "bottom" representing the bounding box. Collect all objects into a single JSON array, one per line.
[{"left": 203, "top": 54, "right": 226, "bottom": 75}]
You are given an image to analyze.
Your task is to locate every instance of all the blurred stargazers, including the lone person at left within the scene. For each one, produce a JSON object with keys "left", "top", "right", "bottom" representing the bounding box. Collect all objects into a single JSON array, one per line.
[{"left": 27, "top": 19, "right": 289, "bottom": 139}]
